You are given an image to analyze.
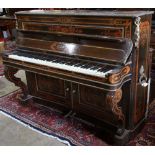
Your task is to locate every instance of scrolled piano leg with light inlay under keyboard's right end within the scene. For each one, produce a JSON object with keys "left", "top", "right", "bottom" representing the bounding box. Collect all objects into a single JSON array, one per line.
[{"left": 107, "top": 89, "right": 124, "bottom": 135}]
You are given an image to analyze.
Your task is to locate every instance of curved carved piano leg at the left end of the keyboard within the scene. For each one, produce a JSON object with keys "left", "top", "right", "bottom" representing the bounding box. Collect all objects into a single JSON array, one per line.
[{"left": 4, "top": 66, "right": 32, "bottom": 104}]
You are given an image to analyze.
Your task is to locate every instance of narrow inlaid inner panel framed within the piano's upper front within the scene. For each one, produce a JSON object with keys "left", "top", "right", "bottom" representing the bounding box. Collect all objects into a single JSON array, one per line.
[{"left": 20, "top": 22, "right": 125, "bottom": 38}]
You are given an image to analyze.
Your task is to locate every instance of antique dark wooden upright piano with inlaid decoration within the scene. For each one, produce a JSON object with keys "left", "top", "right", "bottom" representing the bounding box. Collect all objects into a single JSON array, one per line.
[{"left": 3, "top": 10, "right": 153, "bottom": 145}]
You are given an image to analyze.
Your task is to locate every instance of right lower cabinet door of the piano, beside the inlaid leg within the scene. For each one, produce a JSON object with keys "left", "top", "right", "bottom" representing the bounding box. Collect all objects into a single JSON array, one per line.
[{"left": 77, "top": 85, "right": 116, "bottom": 124}]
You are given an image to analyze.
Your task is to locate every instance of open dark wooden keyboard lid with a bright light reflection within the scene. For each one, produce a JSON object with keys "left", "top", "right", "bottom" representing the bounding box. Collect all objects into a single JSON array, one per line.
[{"left": 17, "top": 36, "right": 133, "bottom": 64}]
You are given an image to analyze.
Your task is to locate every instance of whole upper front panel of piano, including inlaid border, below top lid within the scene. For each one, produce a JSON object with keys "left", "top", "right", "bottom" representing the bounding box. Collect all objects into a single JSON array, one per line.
[{"left": 17, "top": 15, "right": 132, "bottom": 38}]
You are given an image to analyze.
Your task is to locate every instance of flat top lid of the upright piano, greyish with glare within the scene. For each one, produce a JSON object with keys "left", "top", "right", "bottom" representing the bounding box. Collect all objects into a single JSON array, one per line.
[{"left": 15, "top": 10, "right": 154, "bottom": 17}]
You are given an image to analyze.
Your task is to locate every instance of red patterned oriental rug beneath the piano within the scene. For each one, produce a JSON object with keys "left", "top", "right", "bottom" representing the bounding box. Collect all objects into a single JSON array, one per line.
[{"left": 0, "top": 90, "right": 155, "bottom": 146}]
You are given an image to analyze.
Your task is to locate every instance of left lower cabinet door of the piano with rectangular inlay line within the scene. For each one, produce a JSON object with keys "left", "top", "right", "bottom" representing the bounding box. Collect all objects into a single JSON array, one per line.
[{"left": 26, "top": 72, "right": 71, "bottom": 108}]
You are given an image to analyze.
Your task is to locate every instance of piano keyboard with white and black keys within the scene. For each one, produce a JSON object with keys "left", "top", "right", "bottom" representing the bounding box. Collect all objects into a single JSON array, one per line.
[{"left": 8, "top": 52, "right": 112, "bottom": 78}]
